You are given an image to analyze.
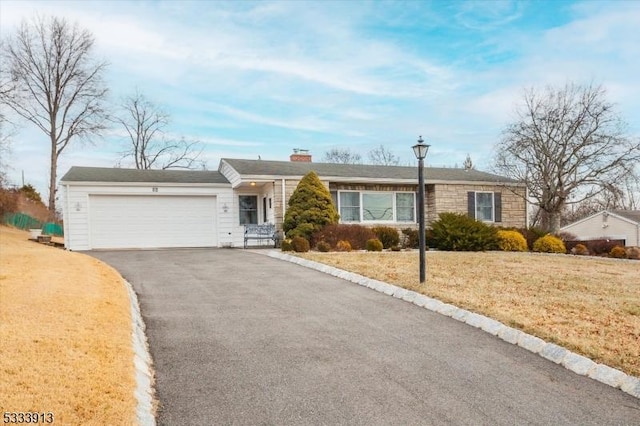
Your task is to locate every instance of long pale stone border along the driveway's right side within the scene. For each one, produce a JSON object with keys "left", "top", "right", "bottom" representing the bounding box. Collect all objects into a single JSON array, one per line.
[{"left": 268, "top": 250, "right": 640, "bottom": 399}]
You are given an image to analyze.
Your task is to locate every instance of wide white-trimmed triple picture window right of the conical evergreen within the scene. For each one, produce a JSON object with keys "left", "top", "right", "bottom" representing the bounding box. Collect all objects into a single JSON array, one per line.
[{"left": 337, "top": 191, "right": 416, "bottom": 223}]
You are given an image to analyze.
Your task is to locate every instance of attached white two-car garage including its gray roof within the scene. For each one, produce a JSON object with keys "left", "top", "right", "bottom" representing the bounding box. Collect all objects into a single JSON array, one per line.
[{"left": 61, "top": 167, "right": 233, "bottom": 250}]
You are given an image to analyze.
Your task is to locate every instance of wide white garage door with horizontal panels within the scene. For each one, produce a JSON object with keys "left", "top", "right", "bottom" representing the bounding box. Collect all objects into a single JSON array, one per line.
[{"left": 89, "top": 195, "right": 218, "bottom": 249}]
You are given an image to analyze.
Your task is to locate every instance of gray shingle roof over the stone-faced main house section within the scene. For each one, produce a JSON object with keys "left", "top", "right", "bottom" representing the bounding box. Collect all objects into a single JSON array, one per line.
[{"left": 223, "top": 158, "right": 517, "bottom": 183}]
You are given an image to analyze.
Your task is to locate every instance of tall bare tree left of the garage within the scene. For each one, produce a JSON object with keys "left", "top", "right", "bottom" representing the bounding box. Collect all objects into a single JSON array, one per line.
[{"left": 0, "top": 17, "right": 107, "bottom": 214}]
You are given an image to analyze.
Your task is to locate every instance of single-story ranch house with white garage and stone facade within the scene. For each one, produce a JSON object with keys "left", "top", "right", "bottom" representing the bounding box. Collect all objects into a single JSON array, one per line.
[{"left": 61, "top": 152, "right": 526, "bottom": 250}]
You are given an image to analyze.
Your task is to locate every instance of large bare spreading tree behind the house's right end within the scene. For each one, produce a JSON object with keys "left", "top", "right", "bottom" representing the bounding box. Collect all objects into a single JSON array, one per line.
[{"left": 494, "top": 84, "right": 640, "bottom": 232}]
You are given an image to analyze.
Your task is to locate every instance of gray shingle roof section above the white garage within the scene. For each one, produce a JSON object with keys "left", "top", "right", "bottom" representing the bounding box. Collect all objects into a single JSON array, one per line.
[{"left": 60, "top": 166, "right": 229, "bottom": 184}]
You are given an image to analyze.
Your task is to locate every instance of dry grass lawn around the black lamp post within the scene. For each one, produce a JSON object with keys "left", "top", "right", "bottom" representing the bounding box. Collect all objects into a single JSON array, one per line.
[{"left": 300, "top": 251, "right": 640, "bottom": 376}]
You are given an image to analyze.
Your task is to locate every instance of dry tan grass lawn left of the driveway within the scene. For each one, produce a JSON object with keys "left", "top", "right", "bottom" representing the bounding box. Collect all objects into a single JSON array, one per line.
[{"left": 0, "top": 226, "right": 136, "bottom": 425}]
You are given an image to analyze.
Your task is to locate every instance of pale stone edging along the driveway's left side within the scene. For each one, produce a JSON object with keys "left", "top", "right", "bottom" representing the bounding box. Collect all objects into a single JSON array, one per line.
[{"left": 122, "top": 279, "right": 156, "bottom": 426}]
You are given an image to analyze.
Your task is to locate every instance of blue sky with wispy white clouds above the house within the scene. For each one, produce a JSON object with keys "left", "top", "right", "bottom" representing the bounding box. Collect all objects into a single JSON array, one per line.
[{"left": 0, "top": 0, "right": 640, "bottom": 200}]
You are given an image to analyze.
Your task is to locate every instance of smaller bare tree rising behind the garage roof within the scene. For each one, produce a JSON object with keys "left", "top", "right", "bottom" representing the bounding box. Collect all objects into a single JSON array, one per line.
[{"left": 114, "top": 92, "right": 205, "bottom": 170}]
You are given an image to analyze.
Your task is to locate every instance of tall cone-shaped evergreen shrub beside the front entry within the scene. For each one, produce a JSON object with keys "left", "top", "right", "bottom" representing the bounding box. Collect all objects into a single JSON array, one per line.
[{"left": 282, "top": 171, "right": 339, "bottom": 241}]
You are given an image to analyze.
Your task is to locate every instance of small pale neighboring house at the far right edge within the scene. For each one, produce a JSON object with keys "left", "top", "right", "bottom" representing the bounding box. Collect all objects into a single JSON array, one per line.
[{"left": 560, "top": 210, "right": 640, "bottom": 247}]
